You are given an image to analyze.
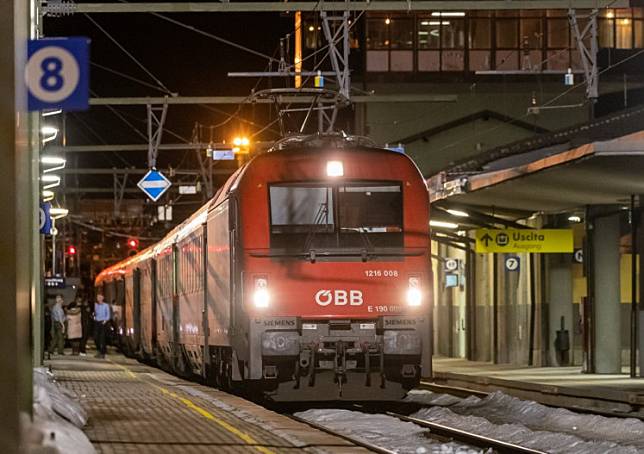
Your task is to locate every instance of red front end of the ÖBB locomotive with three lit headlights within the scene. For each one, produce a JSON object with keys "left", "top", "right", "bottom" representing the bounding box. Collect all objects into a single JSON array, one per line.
[{"left": 239, "top": 136, "right": 431, "bottom": 401}]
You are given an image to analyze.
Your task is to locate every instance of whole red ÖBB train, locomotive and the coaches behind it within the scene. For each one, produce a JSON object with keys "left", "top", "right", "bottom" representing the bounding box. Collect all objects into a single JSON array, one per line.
[{"left": 95, "top": 134, "right": 432, "bottom": 402}]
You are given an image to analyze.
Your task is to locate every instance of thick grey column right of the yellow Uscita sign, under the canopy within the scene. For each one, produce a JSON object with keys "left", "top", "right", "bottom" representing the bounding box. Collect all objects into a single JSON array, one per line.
[{"left": 591, "top": 214, "right": 622, "bottom": 374}]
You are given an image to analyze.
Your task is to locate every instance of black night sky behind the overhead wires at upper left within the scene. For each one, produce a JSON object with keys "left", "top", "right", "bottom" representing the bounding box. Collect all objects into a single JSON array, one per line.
[{"left": 44, "top": 8, "right": 300, "bottom": 166}]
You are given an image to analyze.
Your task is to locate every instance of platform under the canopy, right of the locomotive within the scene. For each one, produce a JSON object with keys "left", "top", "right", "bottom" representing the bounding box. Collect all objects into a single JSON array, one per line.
[{"left": 433, "top": 357, "right": 644, "bottom": 417}]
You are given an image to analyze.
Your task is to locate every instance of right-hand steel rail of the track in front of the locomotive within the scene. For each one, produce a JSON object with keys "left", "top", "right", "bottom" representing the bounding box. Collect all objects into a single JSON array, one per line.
[{"left": 386, "top": 411, "right": 546, "bottom": 454}]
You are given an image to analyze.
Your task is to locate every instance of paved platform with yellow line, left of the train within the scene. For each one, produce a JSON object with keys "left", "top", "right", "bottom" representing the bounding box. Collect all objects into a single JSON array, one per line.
[{"left": 45, "top": 353, "right": 367, "bottom": 454}]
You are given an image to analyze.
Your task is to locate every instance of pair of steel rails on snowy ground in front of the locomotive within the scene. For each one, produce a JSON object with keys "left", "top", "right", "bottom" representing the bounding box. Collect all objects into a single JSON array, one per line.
[{"left": 289, "top": 411, "right": 545, "bottom": 454}]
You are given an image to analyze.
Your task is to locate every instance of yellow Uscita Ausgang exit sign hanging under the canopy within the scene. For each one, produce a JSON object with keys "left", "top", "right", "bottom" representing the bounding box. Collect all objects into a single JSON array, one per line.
[{"left": 476, "top": 229, "right": 573, "bottom": 253}]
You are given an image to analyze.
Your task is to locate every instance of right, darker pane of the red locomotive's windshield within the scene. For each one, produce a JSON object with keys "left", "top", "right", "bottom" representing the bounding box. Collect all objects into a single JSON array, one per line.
[{"left": 338, "top": 185, "right": 402, "bottom": 233}]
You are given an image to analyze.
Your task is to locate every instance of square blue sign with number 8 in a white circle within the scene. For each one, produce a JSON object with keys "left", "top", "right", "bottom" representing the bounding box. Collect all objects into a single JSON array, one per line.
[{"left": 25, "top": 38, "right": 89, "bottom": 111}]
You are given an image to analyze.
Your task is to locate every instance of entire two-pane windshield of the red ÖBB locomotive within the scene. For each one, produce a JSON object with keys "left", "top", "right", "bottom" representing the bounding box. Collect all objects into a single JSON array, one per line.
[{"left": 270, "top": 182, "right": 403, "bottom": 250}]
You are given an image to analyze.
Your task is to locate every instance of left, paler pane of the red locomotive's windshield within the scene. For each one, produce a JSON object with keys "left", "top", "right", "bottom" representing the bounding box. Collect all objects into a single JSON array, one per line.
[{"left": 270, "top": 185, "right": 335, "bottom": 233}]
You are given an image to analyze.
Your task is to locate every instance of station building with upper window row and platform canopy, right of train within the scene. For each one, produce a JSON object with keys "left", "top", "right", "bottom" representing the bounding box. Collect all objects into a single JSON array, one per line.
[{"left": 304, "top": 7, "right": 644, "bottom": 374}]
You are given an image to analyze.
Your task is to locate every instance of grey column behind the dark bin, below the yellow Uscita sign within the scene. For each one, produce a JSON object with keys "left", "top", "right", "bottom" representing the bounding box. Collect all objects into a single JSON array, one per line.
[{"left": 547, "top": 254, "right": 573, "bottom": 366}]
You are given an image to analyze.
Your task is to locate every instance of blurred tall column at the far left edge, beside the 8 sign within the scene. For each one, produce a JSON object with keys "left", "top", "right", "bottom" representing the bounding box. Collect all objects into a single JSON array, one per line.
[{"left": 0, "top": 0, "right": 36, "bottom": 454}]
